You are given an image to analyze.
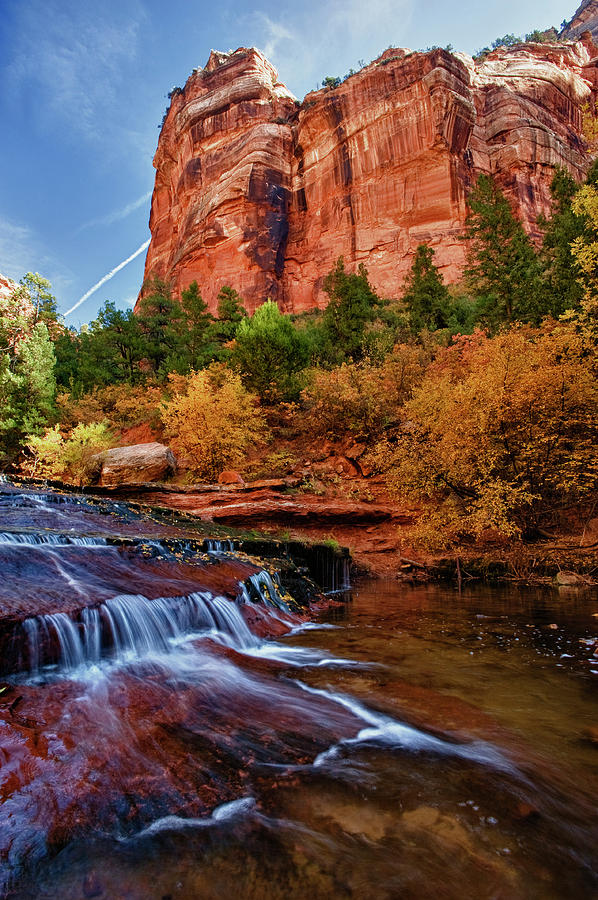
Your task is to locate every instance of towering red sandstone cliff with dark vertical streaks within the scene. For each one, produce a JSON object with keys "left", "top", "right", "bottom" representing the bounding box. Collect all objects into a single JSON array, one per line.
[{"left": 145, "top": 35, "right": 598, "bottom": 312}]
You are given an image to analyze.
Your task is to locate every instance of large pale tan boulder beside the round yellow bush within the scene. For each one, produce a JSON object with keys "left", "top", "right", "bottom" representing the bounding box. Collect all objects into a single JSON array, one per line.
[{"left": 90, "top": 441, "right": 176, "bottom": 485}]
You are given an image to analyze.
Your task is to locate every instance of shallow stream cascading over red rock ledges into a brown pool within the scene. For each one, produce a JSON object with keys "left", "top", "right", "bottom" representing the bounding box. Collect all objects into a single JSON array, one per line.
[{"left": 0, "top": 483, "right": 598, "bottom": 900}]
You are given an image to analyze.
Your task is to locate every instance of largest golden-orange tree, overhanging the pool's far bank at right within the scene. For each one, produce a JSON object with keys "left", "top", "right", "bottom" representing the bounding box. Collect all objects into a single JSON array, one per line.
[{"left": 375, "top": 323, "right": 598, "bottom": 546}]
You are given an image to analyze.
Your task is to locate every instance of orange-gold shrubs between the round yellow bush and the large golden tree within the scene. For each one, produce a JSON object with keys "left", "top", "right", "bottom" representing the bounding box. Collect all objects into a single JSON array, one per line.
[{"left": 302, "top": 344, "right": 427, "bottom": 438}]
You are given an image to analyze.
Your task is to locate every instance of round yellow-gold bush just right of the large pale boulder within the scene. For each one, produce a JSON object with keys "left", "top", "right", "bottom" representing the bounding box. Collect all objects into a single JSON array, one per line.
[{"left": 162, "top": 364, "right": 267, "bottom": 480}]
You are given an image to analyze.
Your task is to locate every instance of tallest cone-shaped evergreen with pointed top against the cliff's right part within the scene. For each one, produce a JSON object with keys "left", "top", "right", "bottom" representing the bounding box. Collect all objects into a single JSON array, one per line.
[{"left": 464, "top": 175, "right": 545, "bottom": 328}]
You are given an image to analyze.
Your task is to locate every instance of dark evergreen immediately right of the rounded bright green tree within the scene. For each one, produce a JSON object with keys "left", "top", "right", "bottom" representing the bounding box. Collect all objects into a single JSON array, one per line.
[{"left": 323, "top": 256, "right": 380, "bottom": 362}]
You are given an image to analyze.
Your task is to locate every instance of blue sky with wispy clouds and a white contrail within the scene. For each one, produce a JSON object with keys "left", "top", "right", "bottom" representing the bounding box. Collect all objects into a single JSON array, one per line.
[{"left": 0, "top": 0, "right": 575, "bottom": 325}]
